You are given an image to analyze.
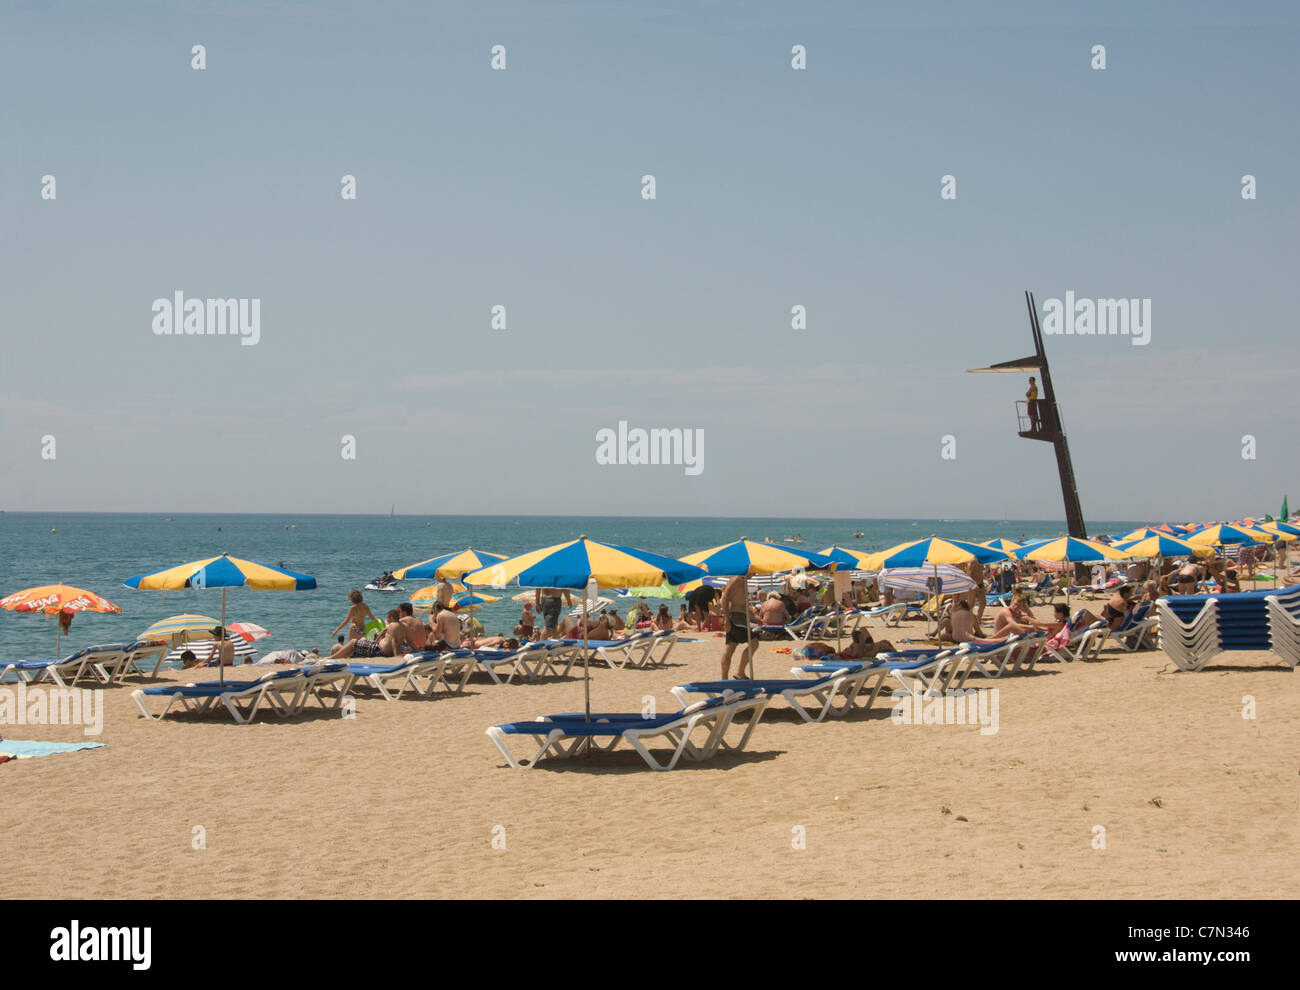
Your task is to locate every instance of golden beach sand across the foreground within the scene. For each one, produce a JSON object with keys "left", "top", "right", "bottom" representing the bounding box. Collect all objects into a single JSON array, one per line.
[{"left": 0, "top": 597, "right": 1300, "bottom": 899}]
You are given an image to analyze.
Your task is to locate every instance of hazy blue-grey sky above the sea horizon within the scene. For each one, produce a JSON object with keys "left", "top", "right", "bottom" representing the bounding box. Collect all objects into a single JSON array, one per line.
[{"left": 0, "top": 0, "right": 1300, "bottom": 520}]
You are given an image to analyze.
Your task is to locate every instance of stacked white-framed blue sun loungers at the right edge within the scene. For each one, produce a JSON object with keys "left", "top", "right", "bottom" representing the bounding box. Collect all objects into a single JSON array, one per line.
[{"left": 1156, "top": 586, "right": 1300, "bottom": 670}]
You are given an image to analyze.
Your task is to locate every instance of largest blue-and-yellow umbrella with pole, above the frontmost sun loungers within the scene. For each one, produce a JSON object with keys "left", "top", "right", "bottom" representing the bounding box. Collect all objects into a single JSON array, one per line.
[{"left": 463, "top": 537, "right": 705, "bottom": 718}]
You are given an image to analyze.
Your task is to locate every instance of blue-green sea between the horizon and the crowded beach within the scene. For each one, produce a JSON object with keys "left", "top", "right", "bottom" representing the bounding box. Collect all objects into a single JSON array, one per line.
[{"left": 0, "top": 512, "right": 1143, "bottom": 662}]
